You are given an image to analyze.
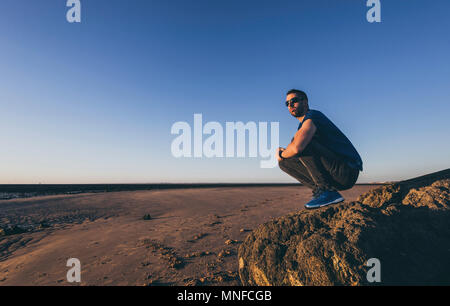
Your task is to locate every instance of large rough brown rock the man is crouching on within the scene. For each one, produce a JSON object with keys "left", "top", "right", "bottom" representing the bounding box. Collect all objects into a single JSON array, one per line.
[{"left": 238, "top": 169, "right": 450, "bottom": 285}]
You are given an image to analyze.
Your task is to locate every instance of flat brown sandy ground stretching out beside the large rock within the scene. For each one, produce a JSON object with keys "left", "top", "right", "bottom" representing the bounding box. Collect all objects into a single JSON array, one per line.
[{"left": 0, "top": 185, "right": 375, "bottom": 286}]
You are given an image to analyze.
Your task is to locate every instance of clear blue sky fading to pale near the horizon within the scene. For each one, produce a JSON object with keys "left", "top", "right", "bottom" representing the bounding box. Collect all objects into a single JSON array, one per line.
[{"left": 0, "top": 0, "right": 450, "bottom": 183}]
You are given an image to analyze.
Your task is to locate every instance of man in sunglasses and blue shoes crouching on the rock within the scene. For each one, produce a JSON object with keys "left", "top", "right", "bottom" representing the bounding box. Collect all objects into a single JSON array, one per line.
[{"left": 277, "top": 89, "right": 362, "bottom": 208}]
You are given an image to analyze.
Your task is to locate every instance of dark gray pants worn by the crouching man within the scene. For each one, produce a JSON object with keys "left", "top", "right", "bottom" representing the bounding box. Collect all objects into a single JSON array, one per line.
[{"left": 278, "top": 138, "right": 359, "bottom": 191}]
